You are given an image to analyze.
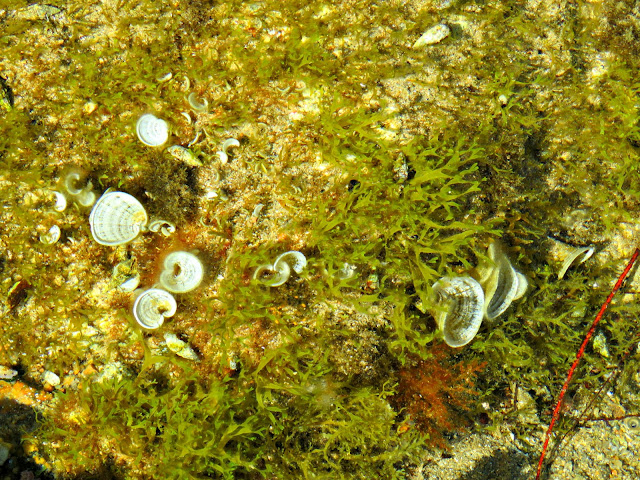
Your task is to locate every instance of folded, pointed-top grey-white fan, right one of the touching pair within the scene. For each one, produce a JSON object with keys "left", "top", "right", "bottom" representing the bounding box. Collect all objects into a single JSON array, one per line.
[{"left": 479, "top": 242, "right": 528, "bottom": 320}]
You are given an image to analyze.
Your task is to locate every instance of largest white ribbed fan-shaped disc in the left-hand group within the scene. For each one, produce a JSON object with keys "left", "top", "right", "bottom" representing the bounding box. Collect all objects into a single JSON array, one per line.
[{"left": 89, "top": 192, "right": 148, "bottom": 246}]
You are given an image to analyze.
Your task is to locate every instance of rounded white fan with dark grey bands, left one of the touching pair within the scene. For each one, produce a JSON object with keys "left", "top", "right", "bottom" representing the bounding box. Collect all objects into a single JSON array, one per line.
[{"left": 433, "top": 277, "right": 484, "bottom": 347}]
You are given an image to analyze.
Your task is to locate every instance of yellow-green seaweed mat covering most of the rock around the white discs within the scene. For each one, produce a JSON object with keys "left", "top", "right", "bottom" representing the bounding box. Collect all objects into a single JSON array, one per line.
[{"left": 0, "top": 1, "right": 640, "bottom": 478}]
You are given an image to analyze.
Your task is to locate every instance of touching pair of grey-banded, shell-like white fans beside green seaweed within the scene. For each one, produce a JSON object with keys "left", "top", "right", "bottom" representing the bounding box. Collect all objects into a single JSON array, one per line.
[{"left": 433, "top": 242, "right": 528, "bottom": 347}]
